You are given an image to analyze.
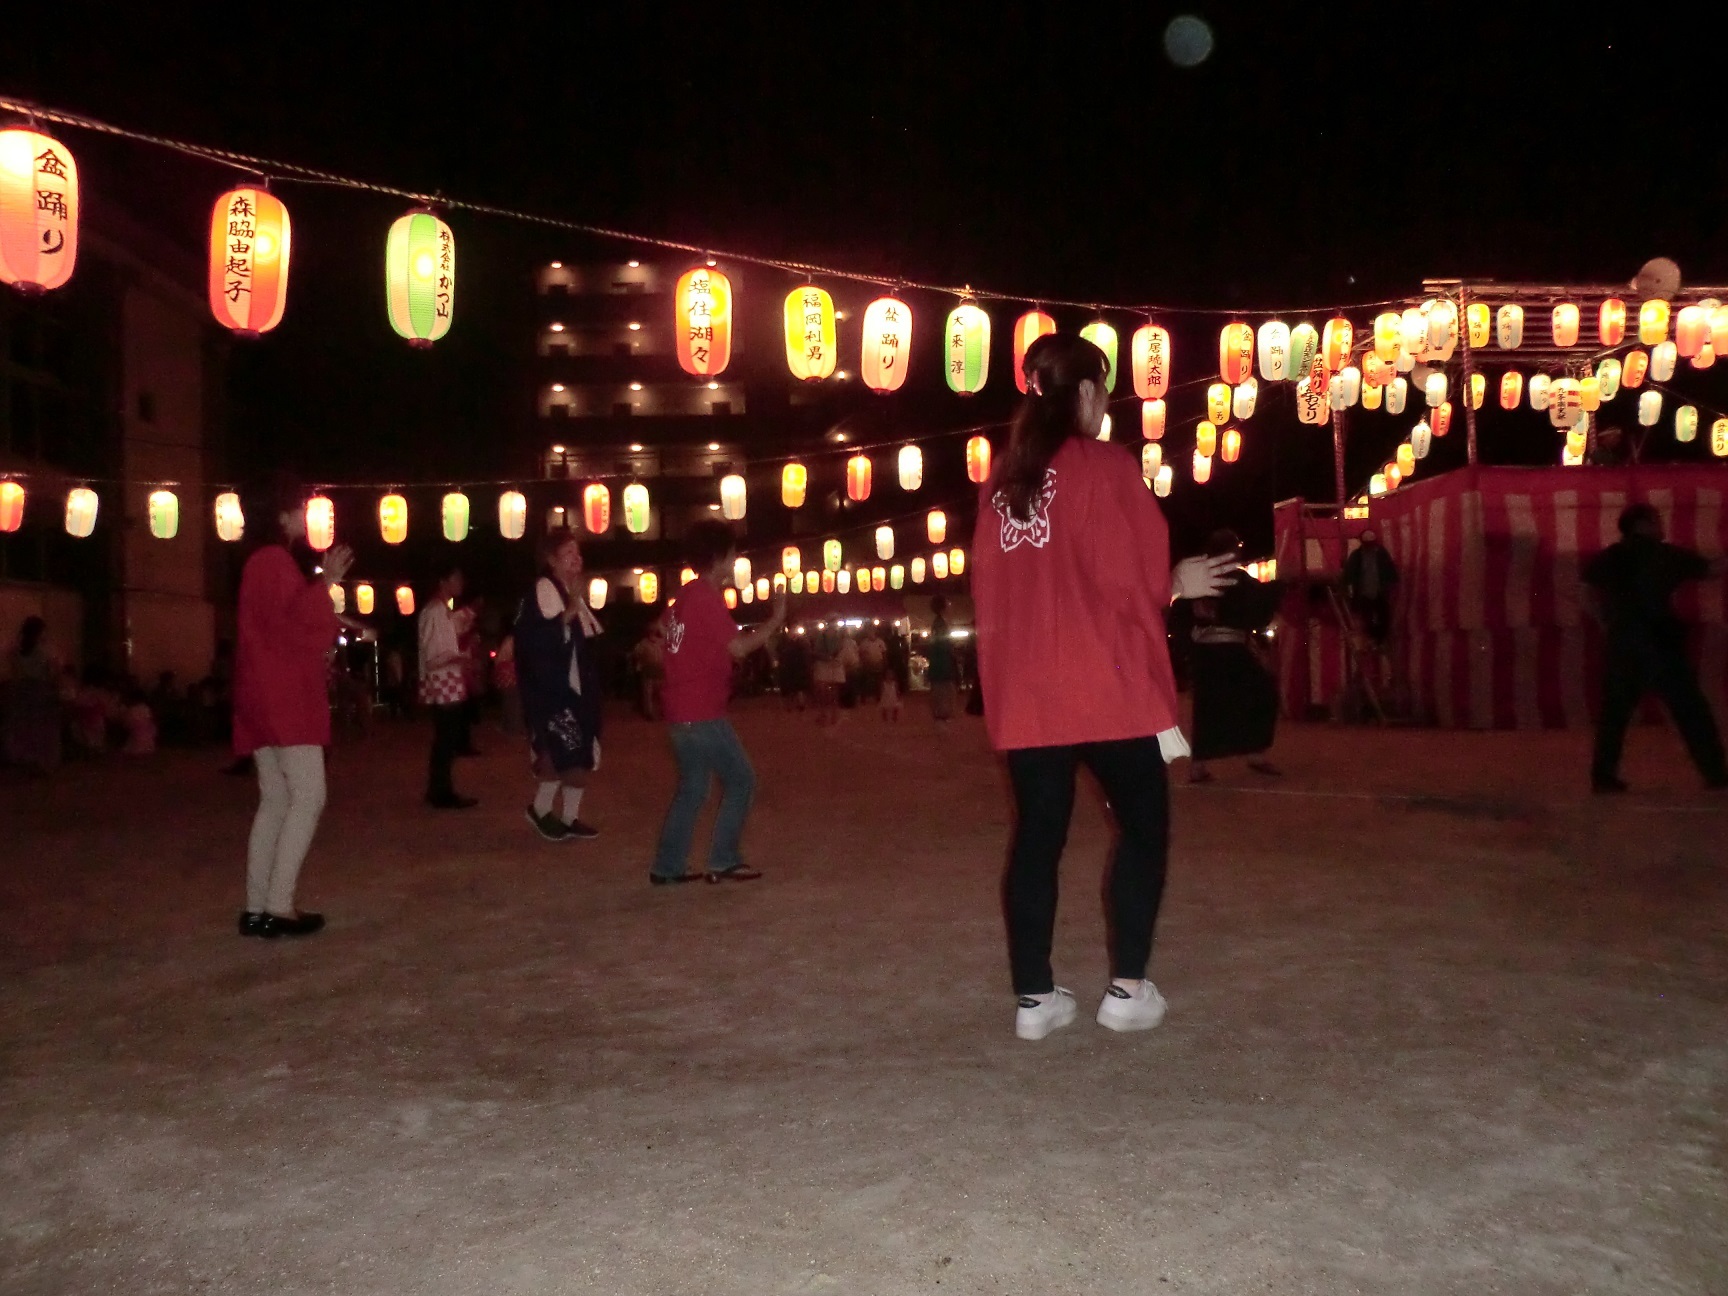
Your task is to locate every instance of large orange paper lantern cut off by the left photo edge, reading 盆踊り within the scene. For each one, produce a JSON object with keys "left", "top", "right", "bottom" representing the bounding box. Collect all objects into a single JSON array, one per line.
[{"left": 0, "top": 127, "right": 78, "bottom": 292}]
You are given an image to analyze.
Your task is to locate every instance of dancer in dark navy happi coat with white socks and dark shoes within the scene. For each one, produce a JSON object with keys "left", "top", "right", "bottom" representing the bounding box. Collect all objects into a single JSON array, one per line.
[{"left": 515, "top": 527, "right": 600, "bottom": 842}]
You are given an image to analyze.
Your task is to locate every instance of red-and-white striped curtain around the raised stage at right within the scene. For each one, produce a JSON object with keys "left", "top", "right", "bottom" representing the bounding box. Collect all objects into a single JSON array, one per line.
[{"left": 1279, "top": 465, "right": 1728, "bottom": 729}]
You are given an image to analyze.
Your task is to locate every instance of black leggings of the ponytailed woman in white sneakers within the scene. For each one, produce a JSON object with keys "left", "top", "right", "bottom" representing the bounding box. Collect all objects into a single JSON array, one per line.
[{"left": 1002, "top": 738, "right": 1170, "bottom": 995}]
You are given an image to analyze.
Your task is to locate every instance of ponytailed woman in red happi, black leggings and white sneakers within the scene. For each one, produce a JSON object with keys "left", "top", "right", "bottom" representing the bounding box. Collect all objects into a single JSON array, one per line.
[{"left": 973, "top": 334, "right": 1236, "bottom": 1040}]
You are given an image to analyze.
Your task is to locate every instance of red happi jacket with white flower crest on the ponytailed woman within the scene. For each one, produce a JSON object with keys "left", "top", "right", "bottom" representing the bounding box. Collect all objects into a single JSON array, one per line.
[{"left": 973, "top": 437, "right": 1177, "bottom": 750}]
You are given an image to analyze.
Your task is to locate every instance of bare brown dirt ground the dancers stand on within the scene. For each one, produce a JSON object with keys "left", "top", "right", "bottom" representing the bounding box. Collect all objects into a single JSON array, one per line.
[{"left": 0, "top": 703, "right": 1728, "bottom": 1296}]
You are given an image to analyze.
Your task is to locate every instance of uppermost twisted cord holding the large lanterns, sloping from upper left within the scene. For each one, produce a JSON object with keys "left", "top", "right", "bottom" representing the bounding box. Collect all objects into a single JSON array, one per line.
[{"left": 0, "top": 95, "right": 1429, "bottom": 316}]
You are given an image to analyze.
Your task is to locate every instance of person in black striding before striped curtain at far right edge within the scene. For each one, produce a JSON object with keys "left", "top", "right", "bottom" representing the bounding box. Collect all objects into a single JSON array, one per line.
[{"left": 1585, "top": 505, "right": 1728, "bottom": 791}]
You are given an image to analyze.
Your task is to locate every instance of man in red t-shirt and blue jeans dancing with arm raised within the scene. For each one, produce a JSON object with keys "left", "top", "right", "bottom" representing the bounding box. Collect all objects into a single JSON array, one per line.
[{"left": 648, "top": 522, "right": 786, "bottom": 886}]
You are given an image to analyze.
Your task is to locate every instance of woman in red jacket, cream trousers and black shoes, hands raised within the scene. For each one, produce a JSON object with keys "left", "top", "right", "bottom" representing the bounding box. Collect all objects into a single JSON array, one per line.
[{"left": 233, "top": 473, "right": 354, "bottom": 937}]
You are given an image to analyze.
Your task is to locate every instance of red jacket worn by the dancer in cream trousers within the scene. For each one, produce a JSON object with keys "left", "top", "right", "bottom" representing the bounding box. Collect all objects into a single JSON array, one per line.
[{"left": 233, "top": 544, "right": 337, "bottom": 755}]
